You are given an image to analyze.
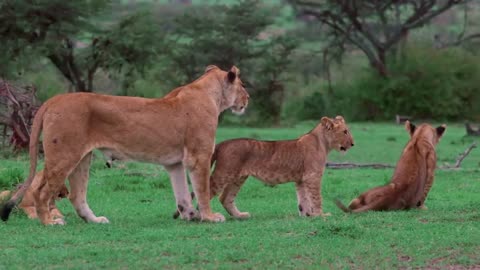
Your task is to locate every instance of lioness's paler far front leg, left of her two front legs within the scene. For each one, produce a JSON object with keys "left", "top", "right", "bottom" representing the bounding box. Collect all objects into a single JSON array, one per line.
[{"left": 165, "top": 163, "right": 200, "bottom": 220}]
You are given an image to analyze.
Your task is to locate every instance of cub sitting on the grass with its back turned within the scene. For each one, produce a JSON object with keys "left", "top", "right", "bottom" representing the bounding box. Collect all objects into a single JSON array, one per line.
[{"left": 336, "top": 121, "right": 446, "bottom": 213}]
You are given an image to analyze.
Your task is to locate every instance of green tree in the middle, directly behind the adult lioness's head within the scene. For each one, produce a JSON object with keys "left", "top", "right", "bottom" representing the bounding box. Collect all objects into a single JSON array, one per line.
[{"left": 162, "top": 0, "right": 296, "bottom": 123}]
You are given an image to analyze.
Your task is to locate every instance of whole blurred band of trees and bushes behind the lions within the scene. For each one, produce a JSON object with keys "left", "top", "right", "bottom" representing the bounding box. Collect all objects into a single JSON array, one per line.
[{"left": 0, "top": 0, "right": 480, "bottom": 125}]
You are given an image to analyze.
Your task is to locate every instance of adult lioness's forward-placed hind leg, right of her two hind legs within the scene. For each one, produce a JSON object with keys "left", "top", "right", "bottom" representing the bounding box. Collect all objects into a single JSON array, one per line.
[{"left": 68, "top": 152, "right": 109, "bottom": 223}]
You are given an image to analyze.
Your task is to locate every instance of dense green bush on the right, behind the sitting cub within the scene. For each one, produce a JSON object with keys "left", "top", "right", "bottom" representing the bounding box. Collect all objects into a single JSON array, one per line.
[{"left": 302, "top": 47, "right": 480, "bottom": 120}]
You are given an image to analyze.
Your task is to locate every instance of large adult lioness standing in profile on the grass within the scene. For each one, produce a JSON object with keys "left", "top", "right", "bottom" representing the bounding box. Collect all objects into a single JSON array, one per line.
[{"left": 1, "top": 66, "right": 249, "bottom": 224}]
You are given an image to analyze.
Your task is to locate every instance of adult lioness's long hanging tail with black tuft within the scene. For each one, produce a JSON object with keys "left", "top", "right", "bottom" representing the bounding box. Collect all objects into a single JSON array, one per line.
[{"left": 0, "top": 104, "right": 46, "bottom": 221}]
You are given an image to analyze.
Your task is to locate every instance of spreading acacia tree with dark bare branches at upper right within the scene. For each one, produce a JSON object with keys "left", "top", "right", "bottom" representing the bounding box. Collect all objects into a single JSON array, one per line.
[{"left": 288, "top": 0, "right": 468, "bottom": 77}]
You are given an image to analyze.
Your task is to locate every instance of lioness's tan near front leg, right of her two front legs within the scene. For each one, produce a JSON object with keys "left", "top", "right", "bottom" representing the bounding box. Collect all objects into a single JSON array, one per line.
[{"left": 187, "top": 155, "right": 225, "bottom": 222}]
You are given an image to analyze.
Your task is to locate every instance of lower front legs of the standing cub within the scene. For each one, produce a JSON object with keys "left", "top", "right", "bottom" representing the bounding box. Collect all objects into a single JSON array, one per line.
[{"left": 303, "top": 174, "right": 330, "bottom": 216}]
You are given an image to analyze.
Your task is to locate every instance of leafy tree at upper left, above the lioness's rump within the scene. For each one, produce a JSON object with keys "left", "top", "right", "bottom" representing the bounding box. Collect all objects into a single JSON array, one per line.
[{"left": 0, "top": 0, "right": 162, "bottom": 92}]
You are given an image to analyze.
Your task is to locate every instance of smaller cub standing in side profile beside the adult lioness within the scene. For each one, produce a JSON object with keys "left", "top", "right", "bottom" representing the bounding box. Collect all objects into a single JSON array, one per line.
[{"left": 174, "top": 116, "right": 353, "bottom": 218}]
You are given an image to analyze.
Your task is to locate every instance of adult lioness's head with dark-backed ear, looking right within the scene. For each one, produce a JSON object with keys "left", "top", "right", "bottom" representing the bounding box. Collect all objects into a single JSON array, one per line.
[{"left": 213, "top": 66, "right": 250, "bottom": 115}]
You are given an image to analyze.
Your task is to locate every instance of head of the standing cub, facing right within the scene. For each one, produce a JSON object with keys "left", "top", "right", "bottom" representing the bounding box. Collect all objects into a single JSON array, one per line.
[{"left": 320, "top": 116, "right": 354, "bottom": 152}]
